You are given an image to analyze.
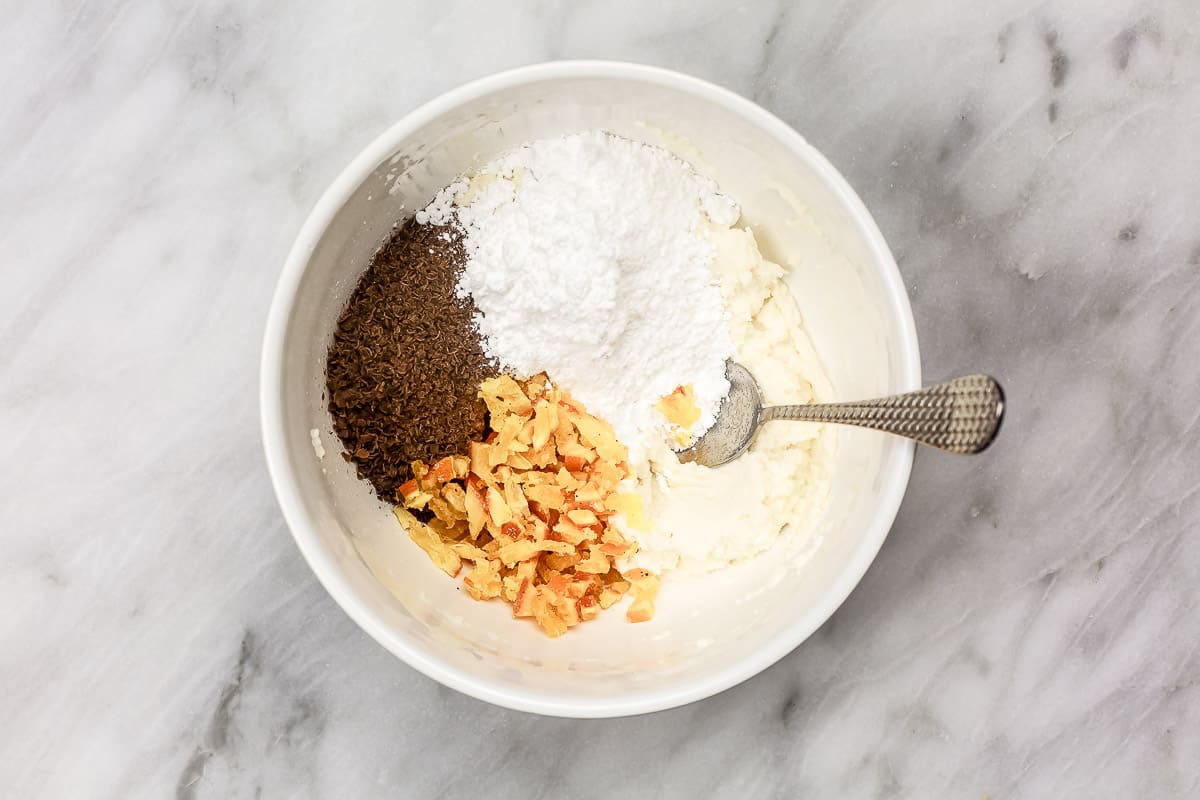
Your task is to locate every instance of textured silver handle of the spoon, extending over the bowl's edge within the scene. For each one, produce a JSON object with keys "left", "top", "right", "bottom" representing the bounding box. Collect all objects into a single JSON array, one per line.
[{"left": 762, "top": 375, "right": 1004, "bottom": 453}]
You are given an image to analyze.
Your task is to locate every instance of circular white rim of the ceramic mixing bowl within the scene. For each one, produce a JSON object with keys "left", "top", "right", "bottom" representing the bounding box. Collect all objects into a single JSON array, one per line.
[{"left": 259, "top": 60, "right": 920, "bottom": 718}]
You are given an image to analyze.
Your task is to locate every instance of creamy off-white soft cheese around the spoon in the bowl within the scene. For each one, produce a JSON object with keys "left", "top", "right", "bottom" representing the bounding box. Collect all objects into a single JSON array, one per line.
[{"left": 629, "top": 224, "right": 834, "bottom": 573}]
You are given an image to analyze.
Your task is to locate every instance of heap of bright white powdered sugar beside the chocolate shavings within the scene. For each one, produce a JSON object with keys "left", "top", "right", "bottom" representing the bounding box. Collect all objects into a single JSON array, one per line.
[{"left": 418, "top": 132, "right": 739, "bottom": 452}]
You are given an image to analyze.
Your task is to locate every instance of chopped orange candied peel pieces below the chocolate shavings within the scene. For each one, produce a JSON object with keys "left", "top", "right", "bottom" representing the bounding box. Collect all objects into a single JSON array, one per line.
[{"left": 395, "top": 374, "right": 657, "bottom": 637}]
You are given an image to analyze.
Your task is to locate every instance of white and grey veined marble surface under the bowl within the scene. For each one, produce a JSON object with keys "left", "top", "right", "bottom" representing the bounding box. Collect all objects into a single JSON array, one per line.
[{"left": 0, "top": 0, "right": 1200, "bottom": 799}]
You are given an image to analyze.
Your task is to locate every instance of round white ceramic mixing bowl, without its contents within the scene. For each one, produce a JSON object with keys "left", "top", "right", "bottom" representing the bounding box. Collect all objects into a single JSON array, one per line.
[{"left": 262, "top": 61, "right": 920, "bottom": 717}]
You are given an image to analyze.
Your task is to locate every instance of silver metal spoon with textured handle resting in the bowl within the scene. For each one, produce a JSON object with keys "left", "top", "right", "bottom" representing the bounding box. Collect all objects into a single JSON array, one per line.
[{"left": 678, "top": 360, "right": 1004, "bottom": 467}]
